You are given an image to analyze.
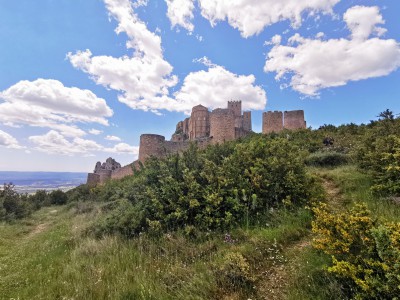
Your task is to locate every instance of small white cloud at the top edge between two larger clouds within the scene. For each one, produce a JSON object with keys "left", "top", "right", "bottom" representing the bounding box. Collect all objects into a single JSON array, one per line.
[{"left": 165, "top": 0, "right": 194, "bottom": 32}]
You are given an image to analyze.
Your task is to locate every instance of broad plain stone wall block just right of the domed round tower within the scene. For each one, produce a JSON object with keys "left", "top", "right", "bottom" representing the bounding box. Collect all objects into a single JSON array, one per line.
[{"left": 210, "top": 109, "right": 235, "bottom": 144}]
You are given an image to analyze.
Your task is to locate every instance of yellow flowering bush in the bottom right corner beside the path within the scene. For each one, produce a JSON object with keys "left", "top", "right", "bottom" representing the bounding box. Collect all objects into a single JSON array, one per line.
[{"left": 312, "top": 204, "right": 400, "bottom": 299}]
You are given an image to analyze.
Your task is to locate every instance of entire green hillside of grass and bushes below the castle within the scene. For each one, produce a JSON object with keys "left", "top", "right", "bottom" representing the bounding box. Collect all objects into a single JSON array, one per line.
[{"left": 0, "top": 111, "right": 400, "bottom": 299}]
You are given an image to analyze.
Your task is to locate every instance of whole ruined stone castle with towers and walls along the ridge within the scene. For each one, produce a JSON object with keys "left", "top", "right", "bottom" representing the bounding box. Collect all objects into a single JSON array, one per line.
[{"left": 87, "top": 101, "right": 306, "bottom": 185}]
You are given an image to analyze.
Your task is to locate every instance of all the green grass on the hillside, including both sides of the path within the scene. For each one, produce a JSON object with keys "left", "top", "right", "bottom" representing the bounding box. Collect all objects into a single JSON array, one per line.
[{"left": 0, "top": 166, "right": 400, "bottom": 300}]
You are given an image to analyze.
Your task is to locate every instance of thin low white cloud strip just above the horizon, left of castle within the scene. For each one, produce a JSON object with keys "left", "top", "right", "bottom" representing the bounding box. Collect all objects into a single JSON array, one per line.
[{"left": 28, "top": 130, "right": 139, "bottom": 156}]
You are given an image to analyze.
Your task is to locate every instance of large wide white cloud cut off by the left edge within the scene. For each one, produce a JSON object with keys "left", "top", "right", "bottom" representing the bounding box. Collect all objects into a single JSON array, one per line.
[{"left": 0, "top": 79, "right": 113, "bottom": 136}]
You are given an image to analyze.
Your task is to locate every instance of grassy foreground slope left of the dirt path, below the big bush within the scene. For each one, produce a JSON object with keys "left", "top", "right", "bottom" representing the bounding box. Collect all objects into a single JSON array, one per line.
[{"left": 0, "top": 204, "right": 310, "bottom": 299}]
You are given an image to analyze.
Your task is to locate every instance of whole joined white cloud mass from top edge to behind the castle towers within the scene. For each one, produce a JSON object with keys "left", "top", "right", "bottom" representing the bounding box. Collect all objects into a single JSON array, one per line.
[{"left": 67, "top": 0, "right": 266, "bottom": 114}]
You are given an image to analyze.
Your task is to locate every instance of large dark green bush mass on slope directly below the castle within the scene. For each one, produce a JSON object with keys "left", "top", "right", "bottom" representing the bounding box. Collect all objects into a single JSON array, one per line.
[{"left": 89, "top": 135, "right": 317, "bottom": 235}]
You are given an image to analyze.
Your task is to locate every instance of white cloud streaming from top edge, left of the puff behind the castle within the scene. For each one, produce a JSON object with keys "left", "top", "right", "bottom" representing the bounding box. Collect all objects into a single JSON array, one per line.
[{"left": 67, "top": 0, "right": 178, "bottom": 111}]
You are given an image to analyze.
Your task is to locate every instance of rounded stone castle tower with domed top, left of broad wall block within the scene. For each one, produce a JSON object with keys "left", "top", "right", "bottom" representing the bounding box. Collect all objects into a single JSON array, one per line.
[{"left": 189, "top": 105, "right": 210, "bottom": 140}]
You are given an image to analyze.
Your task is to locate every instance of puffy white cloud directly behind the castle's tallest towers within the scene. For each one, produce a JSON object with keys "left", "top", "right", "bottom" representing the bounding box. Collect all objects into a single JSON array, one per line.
[{"left": 175, "top": 58, "right": 267, "bottom": 113}]
